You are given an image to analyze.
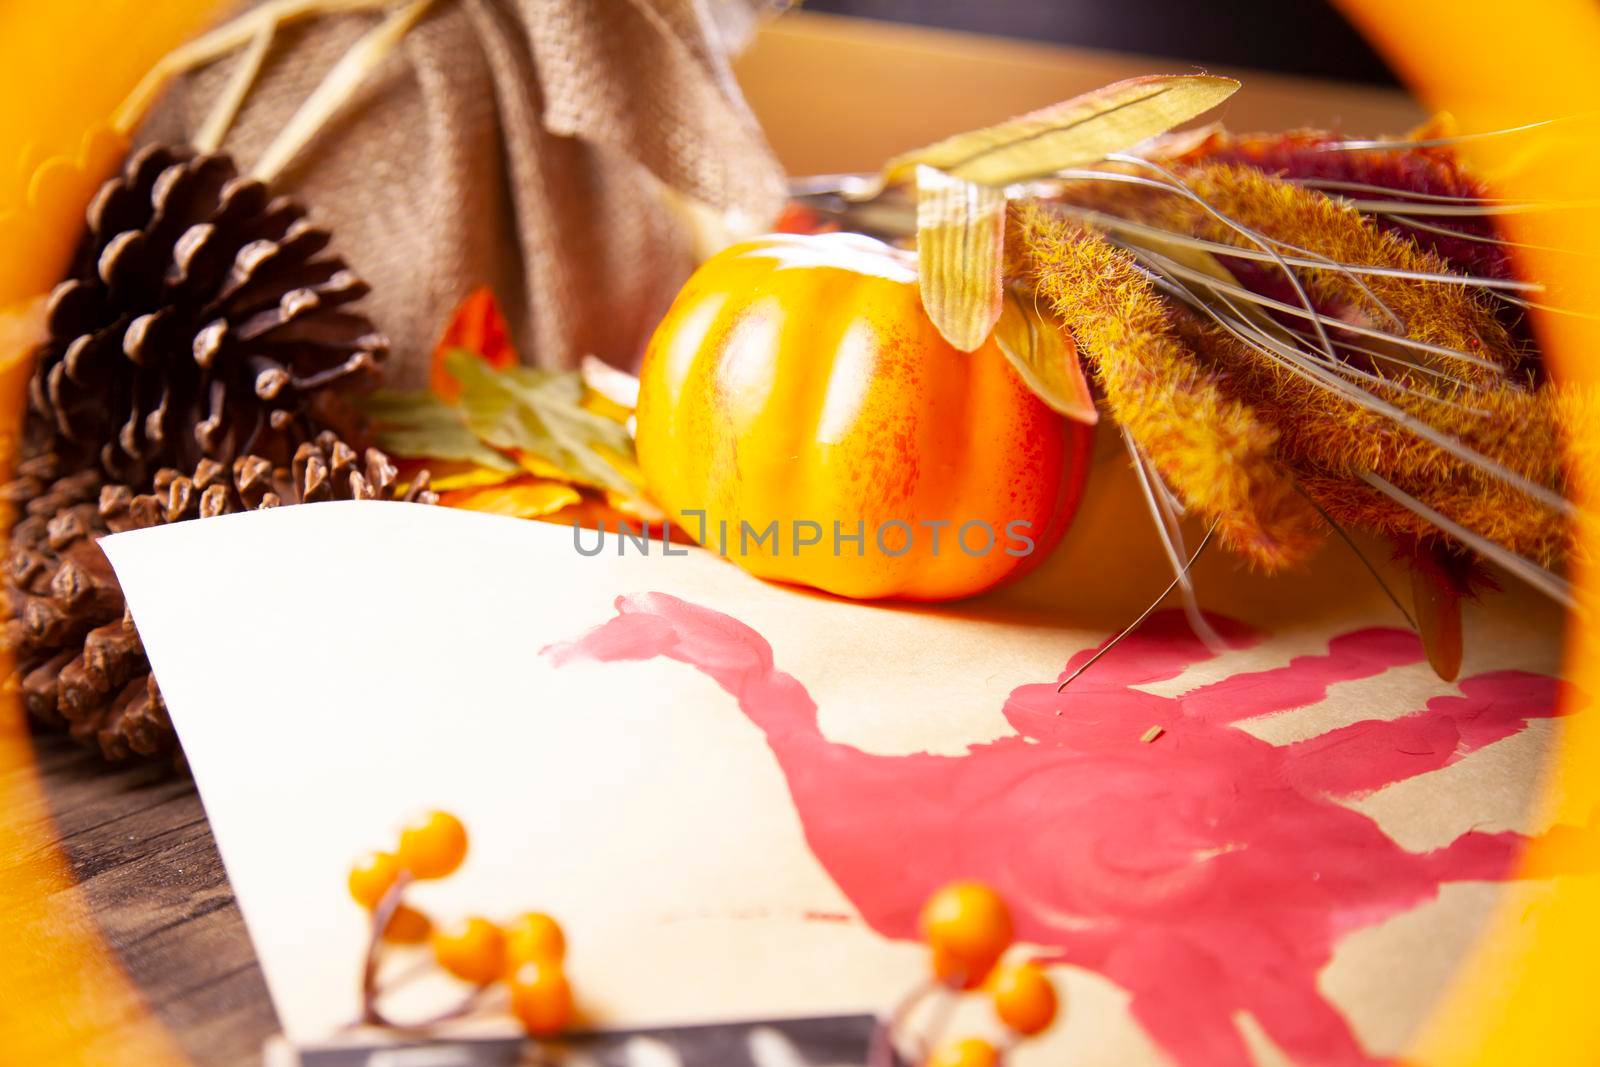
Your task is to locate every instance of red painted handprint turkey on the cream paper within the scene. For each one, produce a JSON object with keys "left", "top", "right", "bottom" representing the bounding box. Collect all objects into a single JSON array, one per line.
[{"left": 546, "top": 593, "right": 1557, "bottom": 1067}]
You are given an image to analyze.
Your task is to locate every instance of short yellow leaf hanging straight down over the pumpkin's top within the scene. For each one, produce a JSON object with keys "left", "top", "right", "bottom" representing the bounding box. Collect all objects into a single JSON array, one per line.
[{"left": 917, "top": 166, "right": 1005, "bottom": 352}]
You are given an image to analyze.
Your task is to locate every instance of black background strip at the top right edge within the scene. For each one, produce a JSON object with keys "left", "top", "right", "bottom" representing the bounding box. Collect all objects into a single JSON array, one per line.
[{"left": 802, "top": 0, "right": 1406, "bottom": 85}]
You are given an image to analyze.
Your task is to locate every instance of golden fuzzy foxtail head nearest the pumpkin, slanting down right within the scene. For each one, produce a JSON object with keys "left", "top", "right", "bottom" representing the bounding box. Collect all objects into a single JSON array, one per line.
[{"left": 1008, "top": 205, "right": 1323, "bottom": 569}]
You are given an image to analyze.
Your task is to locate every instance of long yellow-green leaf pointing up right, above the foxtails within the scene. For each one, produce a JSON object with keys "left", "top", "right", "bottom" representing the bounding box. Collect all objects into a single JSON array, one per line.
[{"left": 883, "top": 74, "right": 1238, "bottom": 186}]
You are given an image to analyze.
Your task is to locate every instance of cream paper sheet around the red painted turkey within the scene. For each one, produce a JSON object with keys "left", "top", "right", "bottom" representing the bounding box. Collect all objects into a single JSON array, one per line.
[{"left": 101, "top": 502, "right": 1560, "bottom": 1067}]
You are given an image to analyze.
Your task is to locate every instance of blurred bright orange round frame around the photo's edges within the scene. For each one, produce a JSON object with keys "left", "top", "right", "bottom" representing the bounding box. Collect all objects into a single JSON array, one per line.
[{"left": 0, "top": 0, "right": 1600, "bottom": 1067}]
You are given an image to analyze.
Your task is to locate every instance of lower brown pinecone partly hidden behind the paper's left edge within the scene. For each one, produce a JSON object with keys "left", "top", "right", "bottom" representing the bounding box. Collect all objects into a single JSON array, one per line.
[{"left": 0, "top": 432, "right": 437, "bottom": 760}]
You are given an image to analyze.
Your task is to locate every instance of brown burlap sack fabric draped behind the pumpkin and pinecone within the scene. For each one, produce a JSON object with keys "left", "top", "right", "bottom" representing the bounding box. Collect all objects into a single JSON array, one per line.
[{"left": 141, "top": 0, "right": 784, "bottom": 386}]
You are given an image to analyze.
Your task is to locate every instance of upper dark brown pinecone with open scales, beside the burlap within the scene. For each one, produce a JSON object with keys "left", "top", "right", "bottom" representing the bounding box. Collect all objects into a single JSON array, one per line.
[{"left": 29, "top": 146, "right": 389, "bottom": 485}]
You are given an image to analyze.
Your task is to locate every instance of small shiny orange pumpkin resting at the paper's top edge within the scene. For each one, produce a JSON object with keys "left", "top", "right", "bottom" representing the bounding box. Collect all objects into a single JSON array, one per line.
[{"left": 638, "top": 234, "right": 1090, "bottom": 600}]
